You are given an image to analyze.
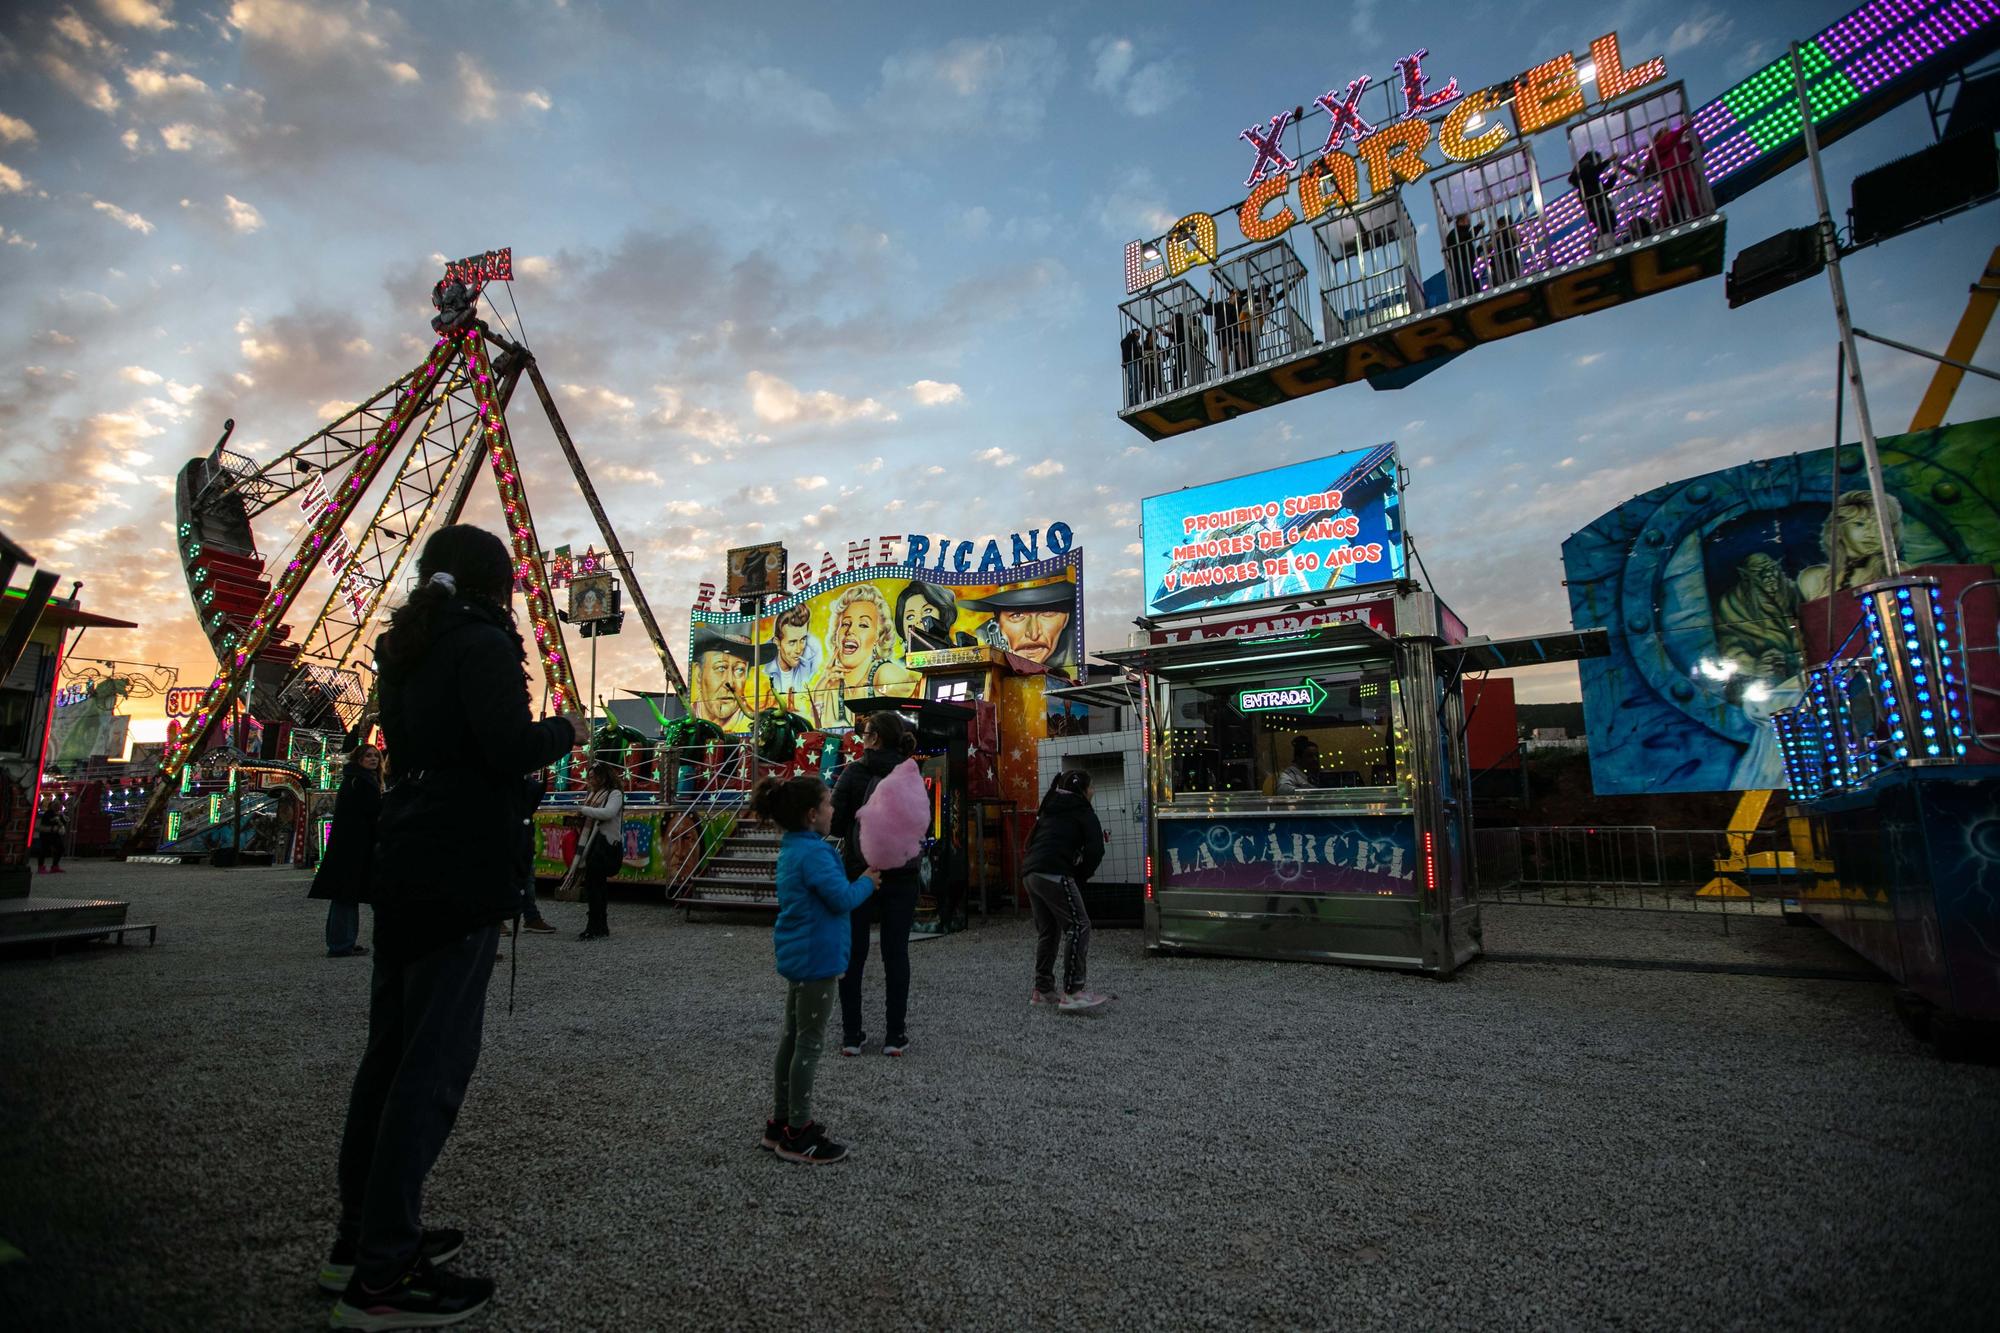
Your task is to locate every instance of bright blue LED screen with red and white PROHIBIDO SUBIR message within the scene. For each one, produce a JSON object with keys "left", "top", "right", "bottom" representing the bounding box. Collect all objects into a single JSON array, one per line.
[{"left": 1140, "top": 444, "right": 1404, "bottom": 616}]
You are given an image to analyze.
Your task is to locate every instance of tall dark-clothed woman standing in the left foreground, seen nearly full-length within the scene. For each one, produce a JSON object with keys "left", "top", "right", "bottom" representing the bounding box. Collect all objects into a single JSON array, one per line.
[{"left": 320, "top": 524, "right": 586, "bottom": 1329}]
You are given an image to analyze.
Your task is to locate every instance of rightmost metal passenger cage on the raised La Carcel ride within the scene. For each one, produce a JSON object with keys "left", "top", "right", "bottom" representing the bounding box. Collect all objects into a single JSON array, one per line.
[{"left": 1556, "top": 84, "right": 1716, "bottom": 262}]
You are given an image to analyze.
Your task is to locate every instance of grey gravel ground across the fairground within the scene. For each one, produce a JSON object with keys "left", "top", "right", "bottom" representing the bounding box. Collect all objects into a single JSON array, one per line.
[{"left": 0, "top": 863, "right": 2000, "bottom": 1331}]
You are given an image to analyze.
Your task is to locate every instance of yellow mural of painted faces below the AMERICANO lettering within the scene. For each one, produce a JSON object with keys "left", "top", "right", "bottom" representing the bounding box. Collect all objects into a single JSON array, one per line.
[{"left": 688, "top": 550, "right": 1084, "bottom": 733}]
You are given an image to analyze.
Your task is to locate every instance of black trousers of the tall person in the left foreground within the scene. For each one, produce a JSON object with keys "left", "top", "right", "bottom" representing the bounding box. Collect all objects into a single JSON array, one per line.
[{"left": 340, "top": 927, "right": 500, "bottom": 1287}]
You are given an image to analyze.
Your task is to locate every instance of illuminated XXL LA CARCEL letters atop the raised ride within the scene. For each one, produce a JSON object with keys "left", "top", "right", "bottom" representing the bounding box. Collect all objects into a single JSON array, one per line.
[{"left": 1126, "top": 32, "right": 1666, "bottom": 292}]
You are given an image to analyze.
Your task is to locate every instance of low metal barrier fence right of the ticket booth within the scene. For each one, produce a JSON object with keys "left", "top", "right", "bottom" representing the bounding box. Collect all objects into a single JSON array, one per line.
[{"left": 1472, "top": 825, "right": 1814, "bottom": 917}]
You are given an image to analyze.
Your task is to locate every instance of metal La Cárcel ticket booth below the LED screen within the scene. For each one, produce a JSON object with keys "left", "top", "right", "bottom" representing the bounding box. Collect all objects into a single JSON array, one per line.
[{"left": 1100, "top": 590, "right": 1602, "bottom": 977}]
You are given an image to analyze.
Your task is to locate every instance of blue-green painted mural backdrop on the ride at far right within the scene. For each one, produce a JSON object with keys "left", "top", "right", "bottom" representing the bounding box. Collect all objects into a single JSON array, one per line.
[{"left": 1562, "top": 418, "right": 2000, "bottom": 795}]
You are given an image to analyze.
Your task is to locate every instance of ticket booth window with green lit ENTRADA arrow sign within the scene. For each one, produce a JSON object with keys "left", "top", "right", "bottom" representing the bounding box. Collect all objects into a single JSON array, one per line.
[{"left": 1166, "top": 667, "right": 1398, "bottom": 797}]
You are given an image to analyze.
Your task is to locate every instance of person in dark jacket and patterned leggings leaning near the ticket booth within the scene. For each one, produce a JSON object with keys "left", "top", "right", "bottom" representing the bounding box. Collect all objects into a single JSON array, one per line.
[{"left": 1020, "top": 769, "right": 1110, "bottom": 1011}]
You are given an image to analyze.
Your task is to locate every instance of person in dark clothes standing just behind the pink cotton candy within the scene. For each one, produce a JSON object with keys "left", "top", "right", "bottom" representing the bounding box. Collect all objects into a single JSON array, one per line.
[{"left": 832, "top": 713, "right": 924, "bottom": 1055}]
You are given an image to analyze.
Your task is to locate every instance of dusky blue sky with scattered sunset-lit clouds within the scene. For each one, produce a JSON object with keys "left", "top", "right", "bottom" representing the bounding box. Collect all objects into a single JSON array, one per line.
[{"left": 0, "top": 0, "right": 2000, "bottom": 735}]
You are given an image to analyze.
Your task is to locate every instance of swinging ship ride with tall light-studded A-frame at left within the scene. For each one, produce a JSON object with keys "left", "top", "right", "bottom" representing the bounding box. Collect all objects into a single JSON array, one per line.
[{"left": 132, "top": 250, "right": 686, "bottom": 849}]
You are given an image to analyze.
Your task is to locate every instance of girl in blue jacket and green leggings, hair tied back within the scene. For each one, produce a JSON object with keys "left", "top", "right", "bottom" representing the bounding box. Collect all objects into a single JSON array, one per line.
[{"left": 750, "top": 777, "right": 880, "bottom": 1165}]
